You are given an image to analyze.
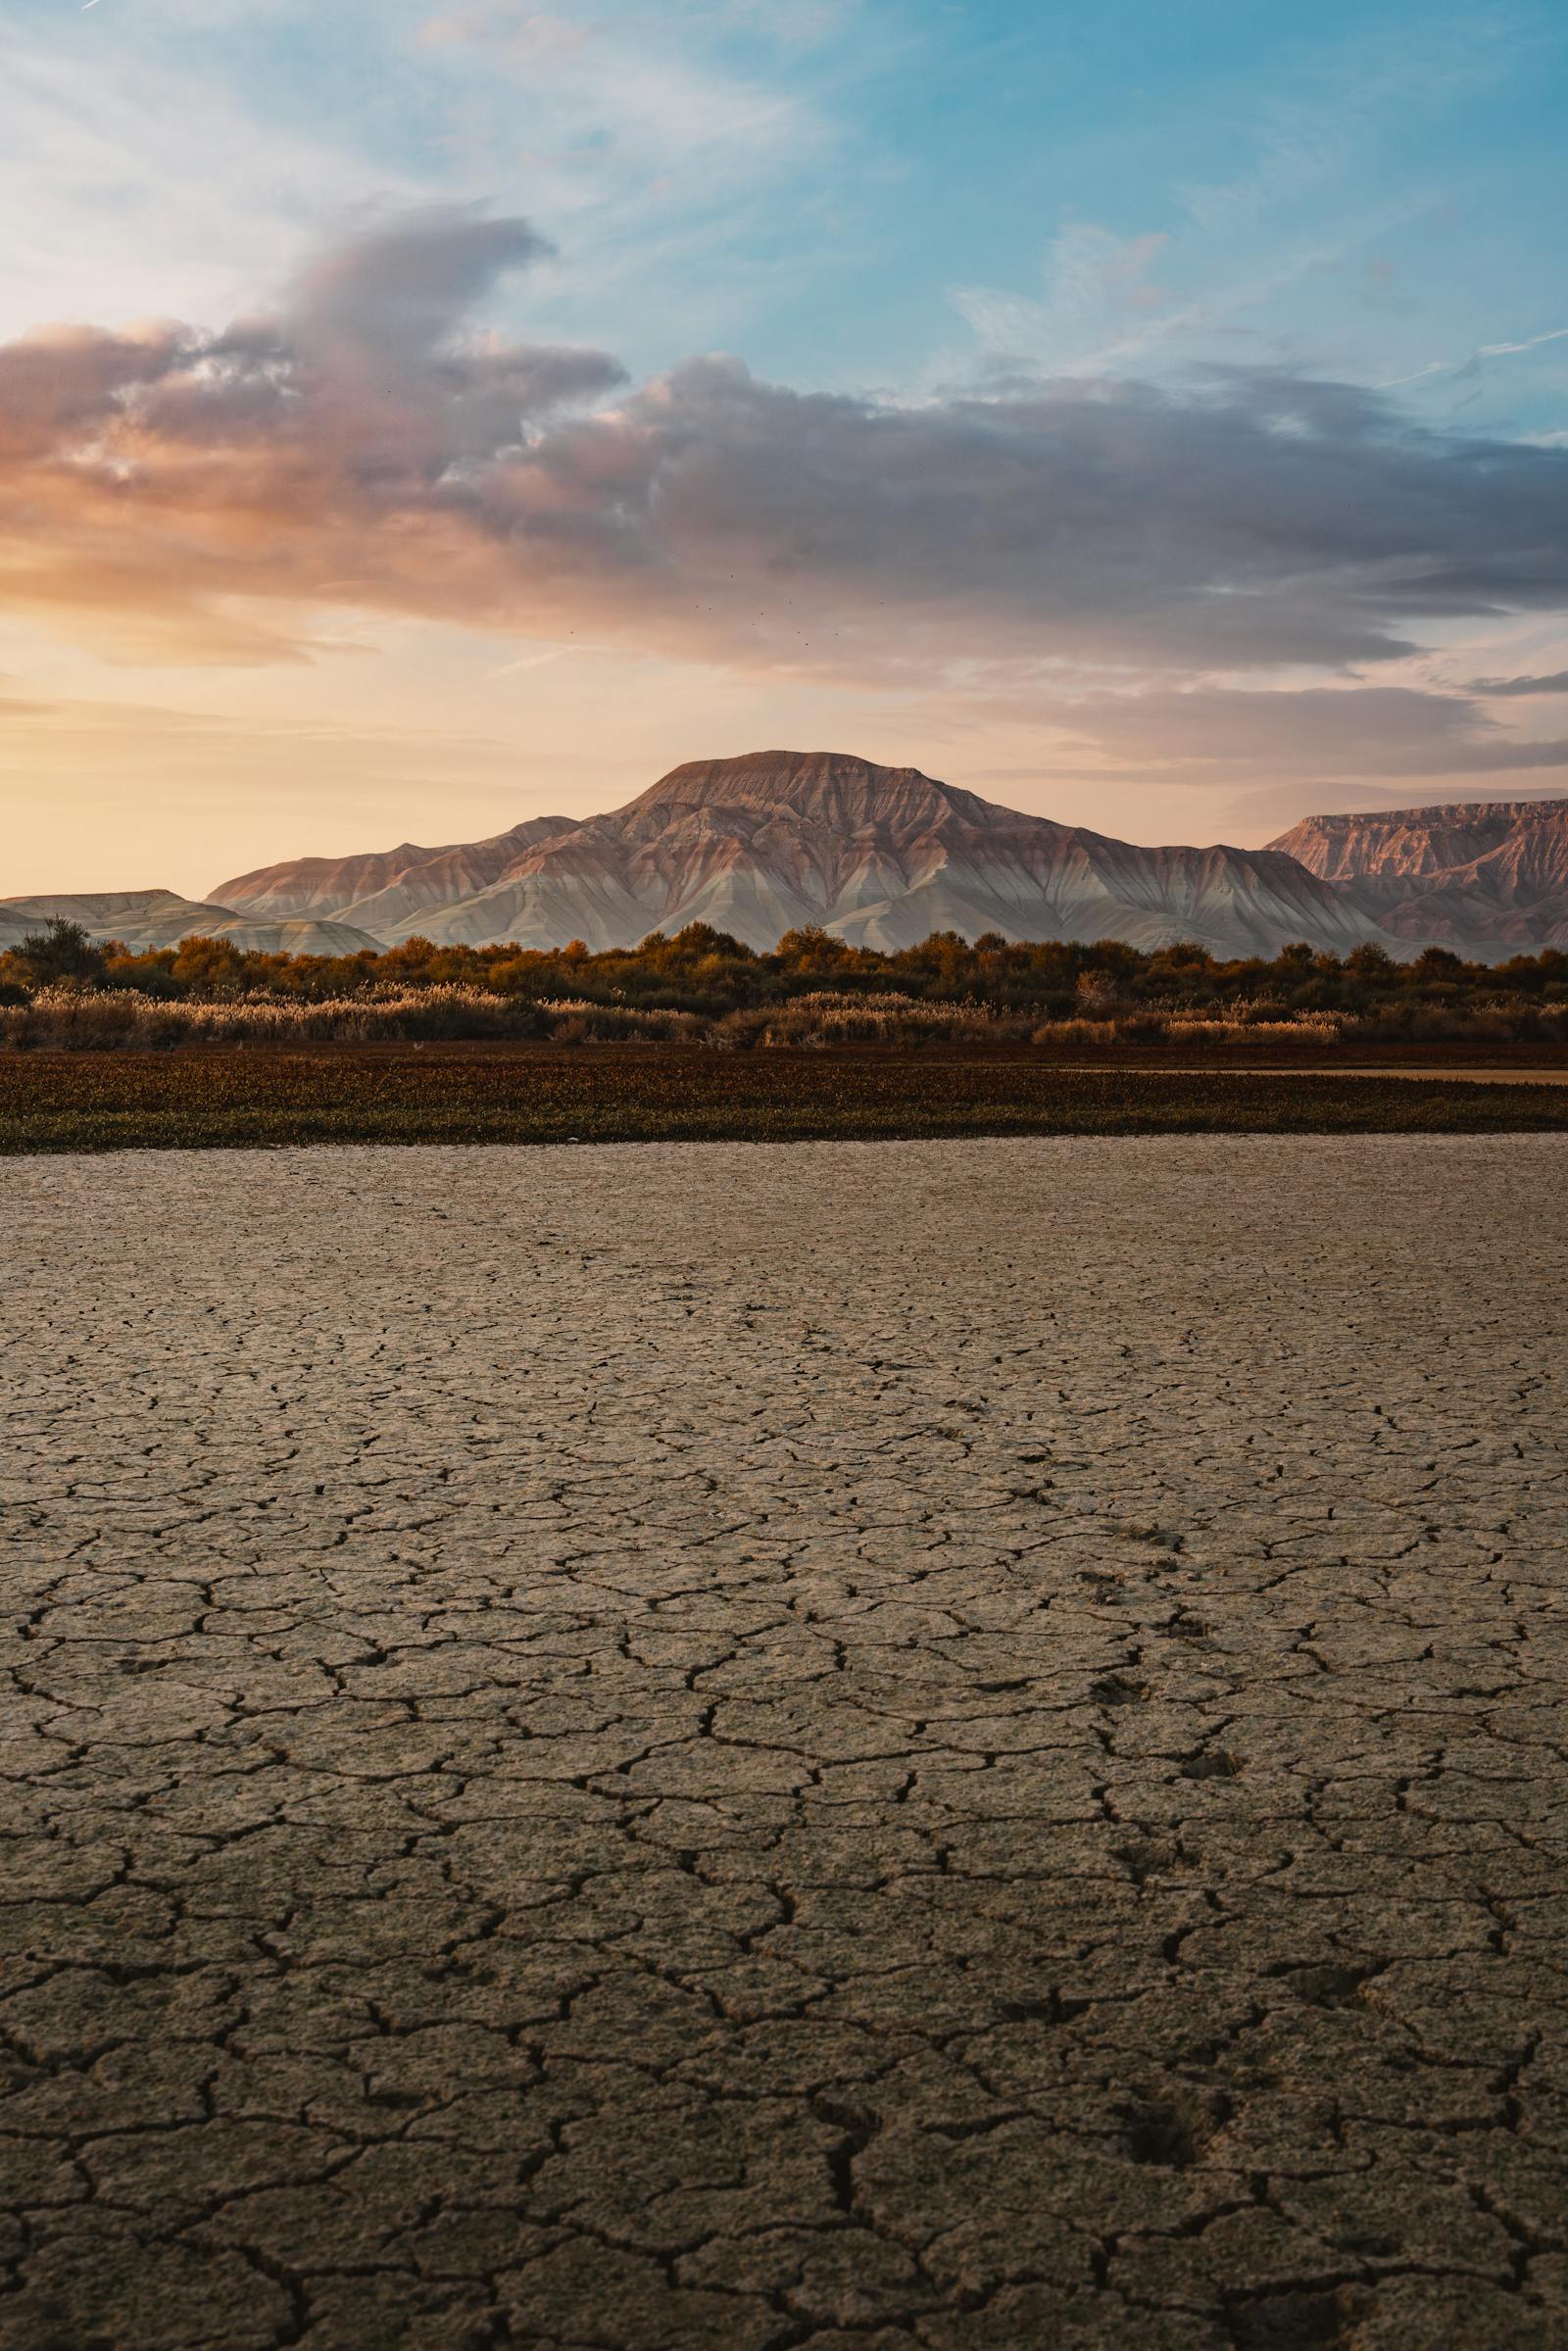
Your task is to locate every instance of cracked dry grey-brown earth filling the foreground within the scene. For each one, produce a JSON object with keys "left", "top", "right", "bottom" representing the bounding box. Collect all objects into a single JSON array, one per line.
[{"left": 0, "top": 1138, "right": 1568, "bottom": 2351}]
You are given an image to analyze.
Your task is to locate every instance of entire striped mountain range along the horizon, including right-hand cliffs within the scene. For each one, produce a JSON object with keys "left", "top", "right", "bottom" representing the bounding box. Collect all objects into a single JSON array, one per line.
[{"left": 0, "top": 750, "right": 1568, "bottom": 959}]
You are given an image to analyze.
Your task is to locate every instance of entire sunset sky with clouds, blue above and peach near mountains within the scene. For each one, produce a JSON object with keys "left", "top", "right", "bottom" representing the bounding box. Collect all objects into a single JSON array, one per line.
[{"left": 0, "top": 0, "right": 1568, "bottom": 896}]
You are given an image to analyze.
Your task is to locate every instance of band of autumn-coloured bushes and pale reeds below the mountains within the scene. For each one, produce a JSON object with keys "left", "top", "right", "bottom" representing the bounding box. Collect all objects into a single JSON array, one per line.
[{"left": 0, "top": 924, "right": 1568, "bottom": 1053}]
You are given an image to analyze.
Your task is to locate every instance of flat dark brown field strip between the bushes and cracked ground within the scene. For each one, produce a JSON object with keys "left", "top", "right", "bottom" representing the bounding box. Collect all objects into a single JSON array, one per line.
[{"left": 0, "top": 1047, "right": 1568, "bottom": 1152}]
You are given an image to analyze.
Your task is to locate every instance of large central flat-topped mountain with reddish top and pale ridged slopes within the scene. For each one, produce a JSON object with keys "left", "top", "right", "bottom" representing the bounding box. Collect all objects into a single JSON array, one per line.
[{"left": 214, "top": 750, "right": 1378, "bottom": 955}]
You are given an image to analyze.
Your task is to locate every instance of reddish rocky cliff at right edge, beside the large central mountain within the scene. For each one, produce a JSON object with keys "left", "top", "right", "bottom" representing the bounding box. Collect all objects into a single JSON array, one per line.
[{"left": 1269, "top": 800, "right": 1568, "bottom": 956}]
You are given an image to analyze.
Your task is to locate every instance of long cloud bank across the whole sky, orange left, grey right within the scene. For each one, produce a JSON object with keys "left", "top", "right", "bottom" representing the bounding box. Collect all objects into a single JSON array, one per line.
[{"left": 0, "top": 210, "right": 1568, "bottom": 681}]
